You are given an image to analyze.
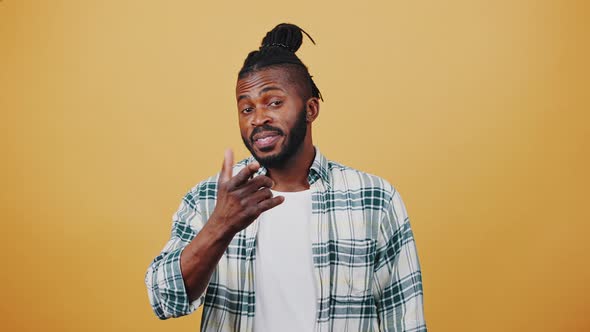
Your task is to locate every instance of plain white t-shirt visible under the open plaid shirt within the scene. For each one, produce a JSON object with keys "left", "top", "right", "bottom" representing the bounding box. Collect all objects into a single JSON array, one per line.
[{"left": 254, "top": 190, "right": 317, "bottom": 332}]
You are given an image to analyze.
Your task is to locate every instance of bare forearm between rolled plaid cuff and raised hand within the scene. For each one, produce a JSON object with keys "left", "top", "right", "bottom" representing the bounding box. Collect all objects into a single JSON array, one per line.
[{"left": 180, "top": 216, "right": 235, "bottom": 301}]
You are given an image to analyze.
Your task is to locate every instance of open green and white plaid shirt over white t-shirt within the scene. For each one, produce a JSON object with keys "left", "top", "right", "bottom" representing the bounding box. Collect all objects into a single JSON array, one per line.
[{"left": 145, "top": 148, "right": 426, "bottom": 332}]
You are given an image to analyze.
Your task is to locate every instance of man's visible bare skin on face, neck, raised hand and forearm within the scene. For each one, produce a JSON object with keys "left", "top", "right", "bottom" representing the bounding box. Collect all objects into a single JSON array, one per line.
[{"left": 180, "top": 67, "right": 320, "bottom": 301}]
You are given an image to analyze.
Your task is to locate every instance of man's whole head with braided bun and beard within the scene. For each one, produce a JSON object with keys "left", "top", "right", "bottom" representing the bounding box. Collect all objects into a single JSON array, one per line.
[{"left": 236, "top": 24, "right": 321, "bottom": 168}]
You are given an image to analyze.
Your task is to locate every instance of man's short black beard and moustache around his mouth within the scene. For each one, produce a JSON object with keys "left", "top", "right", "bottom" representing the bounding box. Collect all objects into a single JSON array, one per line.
[{"left": 242, "top": 106, "right": 307, "bottom": 169}]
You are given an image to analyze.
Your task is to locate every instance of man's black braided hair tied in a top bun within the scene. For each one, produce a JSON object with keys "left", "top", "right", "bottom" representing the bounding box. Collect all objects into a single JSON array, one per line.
[{"left": 238, "top": 23, "right": 324, "bottom": 101}]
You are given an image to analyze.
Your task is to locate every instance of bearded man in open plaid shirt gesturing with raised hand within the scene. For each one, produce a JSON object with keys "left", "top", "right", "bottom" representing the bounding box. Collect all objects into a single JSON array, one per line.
[{"left": 145, "top": 24, "right": 426, "bottom": 331}]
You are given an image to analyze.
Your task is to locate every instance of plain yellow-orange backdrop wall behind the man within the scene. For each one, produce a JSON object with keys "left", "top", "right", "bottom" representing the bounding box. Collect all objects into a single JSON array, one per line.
[{"left": 0, "top": 0, "right": 590, "bottom": 331}]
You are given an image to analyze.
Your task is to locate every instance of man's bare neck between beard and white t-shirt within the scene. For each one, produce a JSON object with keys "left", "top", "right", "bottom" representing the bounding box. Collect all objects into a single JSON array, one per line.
[{"left": 266, "top": 140, "right": 315, "bottom": 192}]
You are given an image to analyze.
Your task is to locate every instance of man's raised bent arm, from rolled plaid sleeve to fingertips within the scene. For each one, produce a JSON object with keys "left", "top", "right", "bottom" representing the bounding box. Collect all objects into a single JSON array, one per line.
[{"left": 145, "top": 153, "right": 283, "bottom": 319}]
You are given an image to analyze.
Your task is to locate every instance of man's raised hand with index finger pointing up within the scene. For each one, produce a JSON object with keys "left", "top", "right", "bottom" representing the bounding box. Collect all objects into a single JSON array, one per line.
[{"left": 210, "top": 149, "right": 284, "bottom": 234}]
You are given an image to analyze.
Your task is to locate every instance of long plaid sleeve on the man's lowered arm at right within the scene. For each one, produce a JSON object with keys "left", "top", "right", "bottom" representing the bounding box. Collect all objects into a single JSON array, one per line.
[{"left": 373, "top": 189, "right": 427, "bottom": 332}]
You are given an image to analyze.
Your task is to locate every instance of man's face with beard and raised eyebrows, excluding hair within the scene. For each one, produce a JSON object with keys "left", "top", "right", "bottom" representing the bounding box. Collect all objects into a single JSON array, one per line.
[{"left": 236, "top": 67, "right": 307, "bottom": 168}]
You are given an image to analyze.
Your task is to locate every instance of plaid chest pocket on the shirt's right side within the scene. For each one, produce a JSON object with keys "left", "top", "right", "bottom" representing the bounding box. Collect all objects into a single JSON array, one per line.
[{"left": 330, "top": 239, "right": 376, "bottom": 300}]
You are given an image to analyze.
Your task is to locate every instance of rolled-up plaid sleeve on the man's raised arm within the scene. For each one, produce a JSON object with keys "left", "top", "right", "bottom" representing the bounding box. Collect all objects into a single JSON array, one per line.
[{"left": 145, "top": 192, "right": 205, "bottom": 319}]
